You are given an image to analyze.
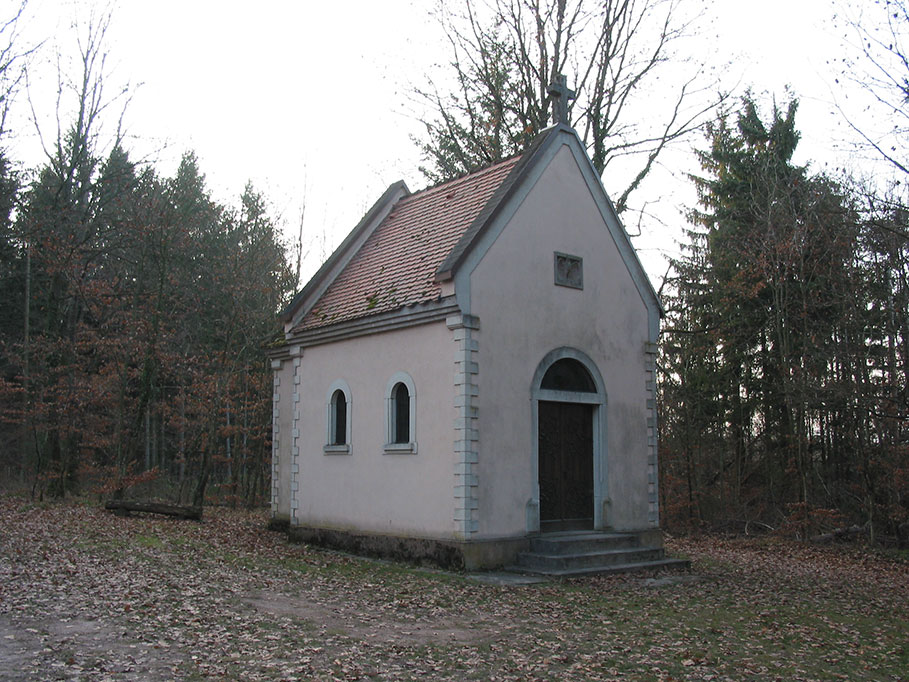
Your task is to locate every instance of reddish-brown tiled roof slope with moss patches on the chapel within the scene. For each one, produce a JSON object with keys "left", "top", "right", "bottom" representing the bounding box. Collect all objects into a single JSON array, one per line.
[{"left": 294, "top": 157, "right": 521, "bottom": 332}]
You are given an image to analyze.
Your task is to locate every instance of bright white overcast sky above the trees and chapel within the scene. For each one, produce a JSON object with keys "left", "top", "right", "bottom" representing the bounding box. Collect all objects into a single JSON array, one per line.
[{"left": 7, "top": 0, "right": 888, "bottom": 286}]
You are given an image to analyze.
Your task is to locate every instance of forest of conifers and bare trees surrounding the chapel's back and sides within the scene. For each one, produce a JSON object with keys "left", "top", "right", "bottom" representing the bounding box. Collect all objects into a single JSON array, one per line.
[{"left": 0, "top": 0, "right": 909, "bottom": 542}]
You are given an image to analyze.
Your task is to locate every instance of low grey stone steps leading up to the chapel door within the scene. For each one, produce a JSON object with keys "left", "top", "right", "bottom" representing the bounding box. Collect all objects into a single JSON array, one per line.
[{"left": 508, "top": 530, "right": 691, "bottom": 578}]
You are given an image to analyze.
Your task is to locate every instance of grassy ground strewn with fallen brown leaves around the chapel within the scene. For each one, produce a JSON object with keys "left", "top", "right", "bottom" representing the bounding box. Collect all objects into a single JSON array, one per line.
[{"left": 0, "top": 498, "right": 909, "bottom": 680}]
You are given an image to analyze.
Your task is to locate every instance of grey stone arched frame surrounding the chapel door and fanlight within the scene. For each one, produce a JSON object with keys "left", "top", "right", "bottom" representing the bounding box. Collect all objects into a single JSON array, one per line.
[{"left": 525, "top": 346, "right": 609, "bottom": 533}]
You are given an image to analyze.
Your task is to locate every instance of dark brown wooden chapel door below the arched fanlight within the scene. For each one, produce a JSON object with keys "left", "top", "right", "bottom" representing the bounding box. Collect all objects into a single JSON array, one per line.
[{"left": 538, "top": 401, "right": 593, "bottom": 531}]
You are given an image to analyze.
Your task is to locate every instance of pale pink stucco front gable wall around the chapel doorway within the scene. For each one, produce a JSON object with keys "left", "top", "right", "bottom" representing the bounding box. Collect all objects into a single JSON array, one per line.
[{"left": 470, "top": 147, "right": 648, "bottom": 537}]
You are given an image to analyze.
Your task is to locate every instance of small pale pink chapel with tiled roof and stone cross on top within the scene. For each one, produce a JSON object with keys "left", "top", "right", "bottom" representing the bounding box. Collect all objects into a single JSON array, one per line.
[{"left": 269, "top": 79, "right": 668, "bottom": 574}]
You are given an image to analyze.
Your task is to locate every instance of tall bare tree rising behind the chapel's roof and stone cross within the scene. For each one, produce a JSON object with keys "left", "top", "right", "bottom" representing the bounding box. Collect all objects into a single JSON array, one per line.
[{"left": 417, "top": 0, "right": 723, "bottom": 211}]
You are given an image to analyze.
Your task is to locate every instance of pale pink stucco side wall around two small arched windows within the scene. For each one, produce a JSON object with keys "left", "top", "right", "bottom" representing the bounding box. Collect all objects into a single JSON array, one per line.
[{"left": 297, "top": 322, "right": 455, "bottom": 538}]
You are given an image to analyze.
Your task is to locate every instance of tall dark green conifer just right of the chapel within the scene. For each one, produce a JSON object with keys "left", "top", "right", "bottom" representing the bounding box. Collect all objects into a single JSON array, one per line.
[{"left": 664, "top": 97, "right": 859, "bottom": 524}]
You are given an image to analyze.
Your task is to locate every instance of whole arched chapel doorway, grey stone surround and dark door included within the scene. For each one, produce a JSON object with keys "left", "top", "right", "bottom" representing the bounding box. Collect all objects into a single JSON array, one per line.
[{"left": 528, "top": 348, "right": 607, "bottom": 532}]
